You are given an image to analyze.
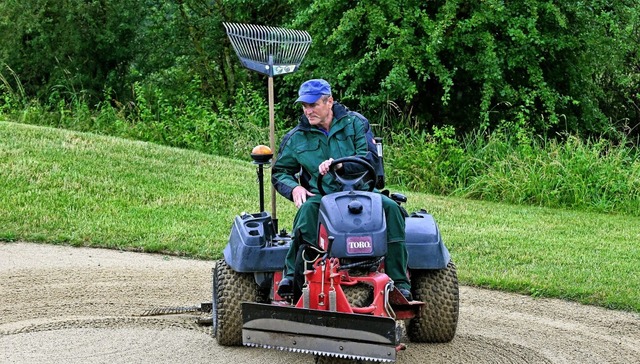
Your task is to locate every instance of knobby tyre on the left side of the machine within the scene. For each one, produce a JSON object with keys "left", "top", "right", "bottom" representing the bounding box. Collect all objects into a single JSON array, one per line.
[{"left": 211, "top": 259, "right": 258, "bottom": 346}]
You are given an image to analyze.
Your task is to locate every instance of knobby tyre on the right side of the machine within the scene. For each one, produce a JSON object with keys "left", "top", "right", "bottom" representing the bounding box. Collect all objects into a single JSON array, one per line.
[{"left": 407, "top": 261, "right": 460, "bottom": 343}]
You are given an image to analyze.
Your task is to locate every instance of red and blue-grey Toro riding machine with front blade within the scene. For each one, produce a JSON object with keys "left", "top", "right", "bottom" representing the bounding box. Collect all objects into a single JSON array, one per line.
[{"left": 212, "top": 157, "right": 459, "bottom": 363}]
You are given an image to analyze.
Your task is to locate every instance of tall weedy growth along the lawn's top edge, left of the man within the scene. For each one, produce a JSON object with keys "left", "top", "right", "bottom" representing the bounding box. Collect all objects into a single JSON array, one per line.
[{"left": 0, "top": 80, "right": 269, "bottom": 164}]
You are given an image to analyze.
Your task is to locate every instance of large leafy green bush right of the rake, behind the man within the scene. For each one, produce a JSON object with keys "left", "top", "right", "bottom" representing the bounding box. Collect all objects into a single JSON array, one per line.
[{"left": 292, "top": 0, "right": 640, "bottom": 137}]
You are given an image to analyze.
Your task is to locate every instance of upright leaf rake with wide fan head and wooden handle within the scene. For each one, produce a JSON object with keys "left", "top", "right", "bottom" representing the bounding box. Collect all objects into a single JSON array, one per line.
[{"left": 223, "top": 23, "right": 311, "bottom": 231}]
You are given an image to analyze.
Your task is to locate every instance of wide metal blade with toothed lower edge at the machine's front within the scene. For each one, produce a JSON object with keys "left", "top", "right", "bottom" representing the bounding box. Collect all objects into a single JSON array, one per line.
[{"left": 242, "top": 303, "right": 398, "bottom": 362}]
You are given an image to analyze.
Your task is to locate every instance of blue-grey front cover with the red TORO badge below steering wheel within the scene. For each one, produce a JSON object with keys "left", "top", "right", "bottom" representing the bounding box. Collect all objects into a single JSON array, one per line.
[{"left": 318, "top": 191, "right": 387, "bottom": 258}]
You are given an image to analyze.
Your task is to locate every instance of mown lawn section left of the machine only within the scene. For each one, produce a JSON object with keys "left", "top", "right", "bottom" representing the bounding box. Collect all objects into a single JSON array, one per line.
[{"left": 0, "top": 119, "right": 284, "bottom": 258}]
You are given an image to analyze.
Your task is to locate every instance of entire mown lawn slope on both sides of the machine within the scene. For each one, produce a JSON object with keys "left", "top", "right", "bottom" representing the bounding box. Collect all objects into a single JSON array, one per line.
[{"left": 0, "top": 121, "right": 640, "bottom": 312}]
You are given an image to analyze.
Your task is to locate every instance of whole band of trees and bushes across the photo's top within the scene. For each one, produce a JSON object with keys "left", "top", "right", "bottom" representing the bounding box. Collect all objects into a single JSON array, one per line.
[{"left": 0, "top": 0, "right": 640, "bottom": 140}]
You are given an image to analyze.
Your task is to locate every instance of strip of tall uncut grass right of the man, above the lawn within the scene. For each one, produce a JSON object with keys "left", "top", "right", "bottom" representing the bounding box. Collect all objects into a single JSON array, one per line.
[{"left": 385, "top": 128, "right": 640, "bottom": 216}]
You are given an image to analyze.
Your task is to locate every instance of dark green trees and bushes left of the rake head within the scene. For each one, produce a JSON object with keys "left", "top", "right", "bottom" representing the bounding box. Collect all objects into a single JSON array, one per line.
[{"left": 0, "top": 0, "right": 288, "bottom": 116}]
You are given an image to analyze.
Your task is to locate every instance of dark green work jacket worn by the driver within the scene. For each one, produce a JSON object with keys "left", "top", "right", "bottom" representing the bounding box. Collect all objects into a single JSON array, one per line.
[{"left": 271, "top": 102, "right": 380, "bottom": 200}]
